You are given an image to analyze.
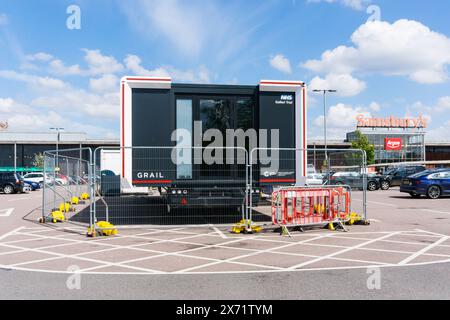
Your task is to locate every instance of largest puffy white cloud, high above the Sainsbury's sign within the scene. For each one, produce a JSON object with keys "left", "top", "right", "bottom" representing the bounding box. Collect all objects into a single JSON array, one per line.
[{"left": 302, "top": 19, "right": 450, "bottom": 84}]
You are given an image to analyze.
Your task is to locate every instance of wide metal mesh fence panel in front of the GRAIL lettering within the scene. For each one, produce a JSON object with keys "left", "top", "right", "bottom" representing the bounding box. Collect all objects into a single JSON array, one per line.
[{"left": 93, "top": 146, "right": 253, "bottom": 228}]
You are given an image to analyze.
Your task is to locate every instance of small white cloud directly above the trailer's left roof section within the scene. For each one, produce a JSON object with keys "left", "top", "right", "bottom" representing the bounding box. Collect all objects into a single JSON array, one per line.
[{"left": 124, "top": 55, "right": 211, "bottom": 83}]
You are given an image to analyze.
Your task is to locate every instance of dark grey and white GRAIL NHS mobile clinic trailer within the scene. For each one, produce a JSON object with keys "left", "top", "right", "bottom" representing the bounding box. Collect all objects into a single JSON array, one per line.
[{"left": 120, "top": 76, "right": 307, "bottom": 210}]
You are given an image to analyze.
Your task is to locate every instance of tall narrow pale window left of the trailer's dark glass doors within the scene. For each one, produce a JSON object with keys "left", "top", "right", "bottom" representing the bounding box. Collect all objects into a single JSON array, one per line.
[{"left": 176, "top": 99, "right": 192, "bottom": 179}]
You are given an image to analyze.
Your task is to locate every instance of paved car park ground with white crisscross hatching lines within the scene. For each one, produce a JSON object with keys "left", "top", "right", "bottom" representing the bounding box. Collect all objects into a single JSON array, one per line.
[{"left": 0, "top": 189, "right": 450, "bottom": 299}]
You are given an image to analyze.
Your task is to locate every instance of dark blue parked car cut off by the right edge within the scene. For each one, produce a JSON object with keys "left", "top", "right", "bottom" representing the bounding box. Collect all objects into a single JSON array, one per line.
[{"left": 400, "top": 169, "right": 450, "bottom": 199}]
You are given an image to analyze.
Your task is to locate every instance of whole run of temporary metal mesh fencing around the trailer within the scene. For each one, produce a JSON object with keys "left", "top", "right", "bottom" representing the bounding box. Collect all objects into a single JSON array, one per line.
[{"left": 42, "top": 146, "right": 367, "bottom": 233}]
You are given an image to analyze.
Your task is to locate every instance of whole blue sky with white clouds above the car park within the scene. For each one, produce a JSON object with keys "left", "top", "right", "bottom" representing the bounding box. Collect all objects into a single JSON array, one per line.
[{"left": 0, "top": 0, "right": 450, "bottom": 140}]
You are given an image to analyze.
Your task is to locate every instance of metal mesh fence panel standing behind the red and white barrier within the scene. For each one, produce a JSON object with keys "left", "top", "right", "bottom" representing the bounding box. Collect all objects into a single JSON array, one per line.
[{"left": 247, "top": 148, "right": 368, "bottom": 228}]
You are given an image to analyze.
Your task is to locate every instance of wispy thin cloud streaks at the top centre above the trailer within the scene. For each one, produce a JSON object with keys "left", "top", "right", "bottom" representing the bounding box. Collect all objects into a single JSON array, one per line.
[{"left": 119, "top": 0, "right": 270, "bottom": 62}]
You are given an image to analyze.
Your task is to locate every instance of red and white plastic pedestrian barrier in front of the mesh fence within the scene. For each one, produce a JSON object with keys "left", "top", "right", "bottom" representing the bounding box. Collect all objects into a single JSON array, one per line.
[{"left": 272, "top": 187, "right": 351, "bottom": 226}]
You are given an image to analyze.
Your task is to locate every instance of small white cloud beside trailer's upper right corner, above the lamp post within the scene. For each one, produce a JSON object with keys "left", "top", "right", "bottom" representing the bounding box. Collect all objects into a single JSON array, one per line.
[{"left": 309, "top": 73, "right": 366, "bottom": 97}]
